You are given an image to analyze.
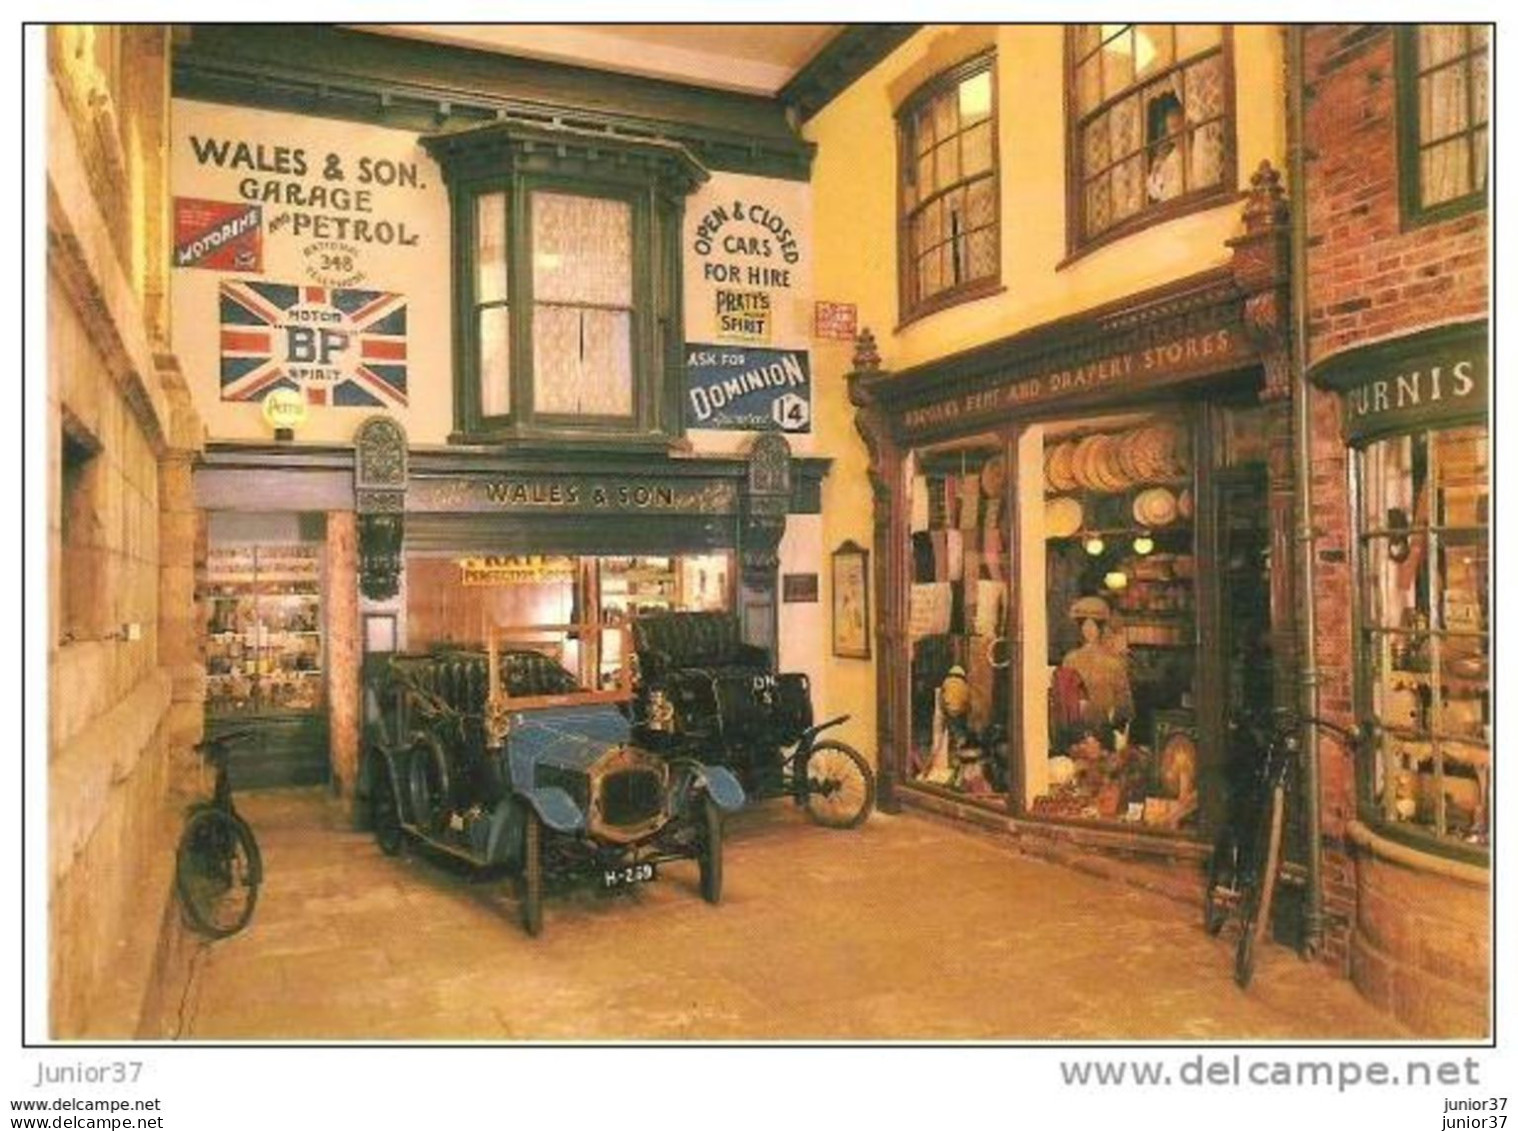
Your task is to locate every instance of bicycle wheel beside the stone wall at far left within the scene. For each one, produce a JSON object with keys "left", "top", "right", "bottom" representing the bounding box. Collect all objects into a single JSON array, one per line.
[{"left": 175, "top": 809, "right": 264, "bottom": 938}]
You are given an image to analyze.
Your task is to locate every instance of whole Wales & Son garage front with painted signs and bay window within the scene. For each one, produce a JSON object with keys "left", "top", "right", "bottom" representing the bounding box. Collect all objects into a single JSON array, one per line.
[{"left": 172, "top": 26, "right": 829, "bottom": 795}]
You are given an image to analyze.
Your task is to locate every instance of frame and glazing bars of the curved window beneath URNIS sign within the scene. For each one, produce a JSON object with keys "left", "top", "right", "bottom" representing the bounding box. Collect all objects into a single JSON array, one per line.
[{"left": 1348, "top": 411, "right": 1494, "bottom": 865}]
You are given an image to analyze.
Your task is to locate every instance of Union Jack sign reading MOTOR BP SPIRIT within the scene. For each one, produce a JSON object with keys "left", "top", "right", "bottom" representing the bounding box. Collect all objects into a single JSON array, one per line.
[{"left": 222, "top": 279, "right": 407, "bottom": 407}]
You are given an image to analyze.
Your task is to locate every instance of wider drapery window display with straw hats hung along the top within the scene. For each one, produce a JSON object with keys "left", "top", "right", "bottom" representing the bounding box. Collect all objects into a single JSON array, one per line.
[{"left": 1029, "top": 416, "right": 1199, "bottom": 829}]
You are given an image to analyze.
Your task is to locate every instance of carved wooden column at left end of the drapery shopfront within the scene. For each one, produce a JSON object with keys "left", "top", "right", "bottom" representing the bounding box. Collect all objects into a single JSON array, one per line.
[{"left": 849, "top": 329, "right": 911, "bottom": 812}]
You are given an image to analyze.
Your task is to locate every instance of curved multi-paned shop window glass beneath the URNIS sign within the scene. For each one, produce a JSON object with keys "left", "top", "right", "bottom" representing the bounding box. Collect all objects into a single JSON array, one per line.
[{"left": 1359, "top": 425, "right": 1492, "bottom": 846}]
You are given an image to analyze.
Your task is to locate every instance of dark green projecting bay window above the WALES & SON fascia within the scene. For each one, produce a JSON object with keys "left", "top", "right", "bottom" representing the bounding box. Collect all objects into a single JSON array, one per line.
[{"left": 422, "top": 120, "right": 707, "bottom": 446}]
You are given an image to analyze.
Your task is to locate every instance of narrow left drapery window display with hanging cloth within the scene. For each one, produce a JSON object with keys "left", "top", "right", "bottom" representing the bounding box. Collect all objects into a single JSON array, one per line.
[{"left": 908, "top": 439, "right": 1013, "bottom": 800}]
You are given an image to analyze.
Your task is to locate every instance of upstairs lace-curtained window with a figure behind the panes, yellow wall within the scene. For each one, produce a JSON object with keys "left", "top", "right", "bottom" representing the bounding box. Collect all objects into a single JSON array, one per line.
[{"left": 1066, "top": 24, "right": 1236, "bottom": 252}]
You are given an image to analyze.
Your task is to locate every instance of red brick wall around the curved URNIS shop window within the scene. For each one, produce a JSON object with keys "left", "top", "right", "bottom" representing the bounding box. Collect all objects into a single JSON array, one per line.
[{"left": 1304, "top": 24, "right": 1489, "bottom": 1032}]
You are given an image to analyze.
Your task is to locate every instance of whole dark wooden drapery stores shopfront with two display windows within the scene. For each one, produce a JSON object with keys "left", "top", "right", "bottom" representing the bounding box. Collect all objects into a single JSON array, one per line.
[{"left": 850, "top": 167, "right": 1295, "bottom": 859}]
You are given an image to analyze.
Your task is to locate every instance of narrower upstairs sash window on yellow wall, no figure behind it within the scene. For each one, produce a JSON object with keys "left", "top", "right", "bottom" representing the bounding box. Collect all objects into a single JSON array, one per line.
[{"left": 897, "top": 55, "right": 1002, "bottom": 322}]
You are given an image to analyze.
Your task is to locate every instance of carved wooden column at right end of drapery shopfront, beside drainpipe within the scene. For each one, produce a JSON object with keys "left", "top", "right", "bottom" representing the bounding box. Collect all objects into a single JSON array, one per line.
[{"left": 1228, "top": 161, "right": 1298, "bottom": 707}]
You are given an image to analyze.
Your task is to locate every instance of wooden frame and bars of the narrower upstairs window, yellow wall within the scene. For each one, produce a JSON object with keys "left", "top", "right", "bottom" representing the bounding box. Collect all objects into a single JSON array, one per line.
[{"left": 894, "top": 47, "right": 1003, "bottom": 329}]
